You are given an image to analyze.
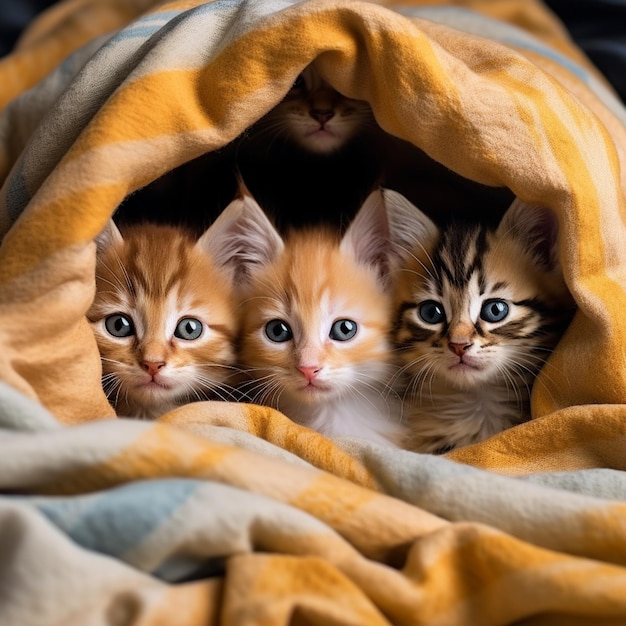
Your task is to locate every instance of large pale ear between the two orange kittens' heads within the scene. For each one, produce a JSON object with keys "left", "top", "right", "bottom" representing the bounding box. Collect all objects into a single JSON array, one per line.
[{"left": 197, "top": 194, "right": 284, "bottom": 283}]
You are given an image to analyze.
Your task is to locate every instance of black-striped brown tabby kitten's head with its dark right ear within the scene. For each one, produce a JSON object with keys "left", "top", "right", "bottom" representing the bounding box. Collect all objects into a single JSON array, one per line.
[{"left": 395, "top": 203, "right": 572, "bottom": 393}]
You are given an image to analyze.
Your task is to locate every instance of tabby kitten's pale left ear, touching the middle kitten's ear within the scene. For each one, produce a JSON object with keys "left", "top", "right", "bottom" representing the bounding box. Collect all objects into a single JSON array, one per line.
[{"left": 383, "top": 189, "right": 440, "bottom": 263}]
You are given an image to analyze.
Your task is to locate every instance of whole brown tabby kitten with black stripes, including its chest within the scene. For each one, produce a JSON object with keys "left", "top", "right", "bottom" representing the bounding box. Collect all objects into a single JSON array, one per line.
[{"left": 395, "top": 195, "right": 573, "bottom": 453}]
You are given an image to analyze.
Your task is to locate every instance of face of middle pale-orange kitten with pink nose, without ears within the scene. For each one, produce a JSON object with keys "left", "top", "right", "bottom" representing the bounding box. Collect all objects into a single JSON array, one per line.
[{"left": 241, "top": 233, "right": 390, "bottom": 404}]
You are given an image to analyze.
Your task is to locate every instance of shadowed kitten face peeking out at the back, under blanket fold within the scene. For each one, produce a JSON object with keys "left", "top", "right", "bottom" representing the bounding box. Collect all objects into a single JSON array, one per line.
[{"left": 250, "top": 66, "right": 375, "bottom": 154}]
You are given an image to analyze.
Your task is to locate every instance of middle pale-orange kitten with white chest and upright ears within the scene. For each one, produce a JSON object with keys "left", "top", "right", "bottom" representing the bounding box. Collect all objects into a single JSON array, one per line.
[{"left": 210, "top": 185, "right": 414, "bottom": 445}]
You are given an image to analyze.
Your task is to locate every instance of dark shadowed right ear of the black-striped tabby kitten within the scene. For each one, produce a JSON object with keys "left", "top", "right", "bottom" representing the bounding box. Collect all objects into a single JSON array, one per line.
[{"left": 497, "top": 198, "right": 559, "bottom": 270}]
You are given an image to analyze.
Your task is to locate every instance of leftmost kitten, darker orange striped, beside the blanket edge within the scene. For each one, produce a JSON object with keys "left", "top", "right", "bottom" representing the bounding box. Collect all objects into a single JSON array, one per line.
[{"left": 87, "top": 219, "right": 241, "bottom": 418}]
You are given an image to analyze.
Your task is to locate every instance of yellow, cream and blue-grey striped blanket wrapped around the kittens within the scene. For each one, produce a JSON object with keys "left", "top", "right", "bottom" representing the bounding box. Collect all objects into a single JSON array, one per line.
[{"left": 0, "top": 0, "right": 626, "bottom": 626}]
